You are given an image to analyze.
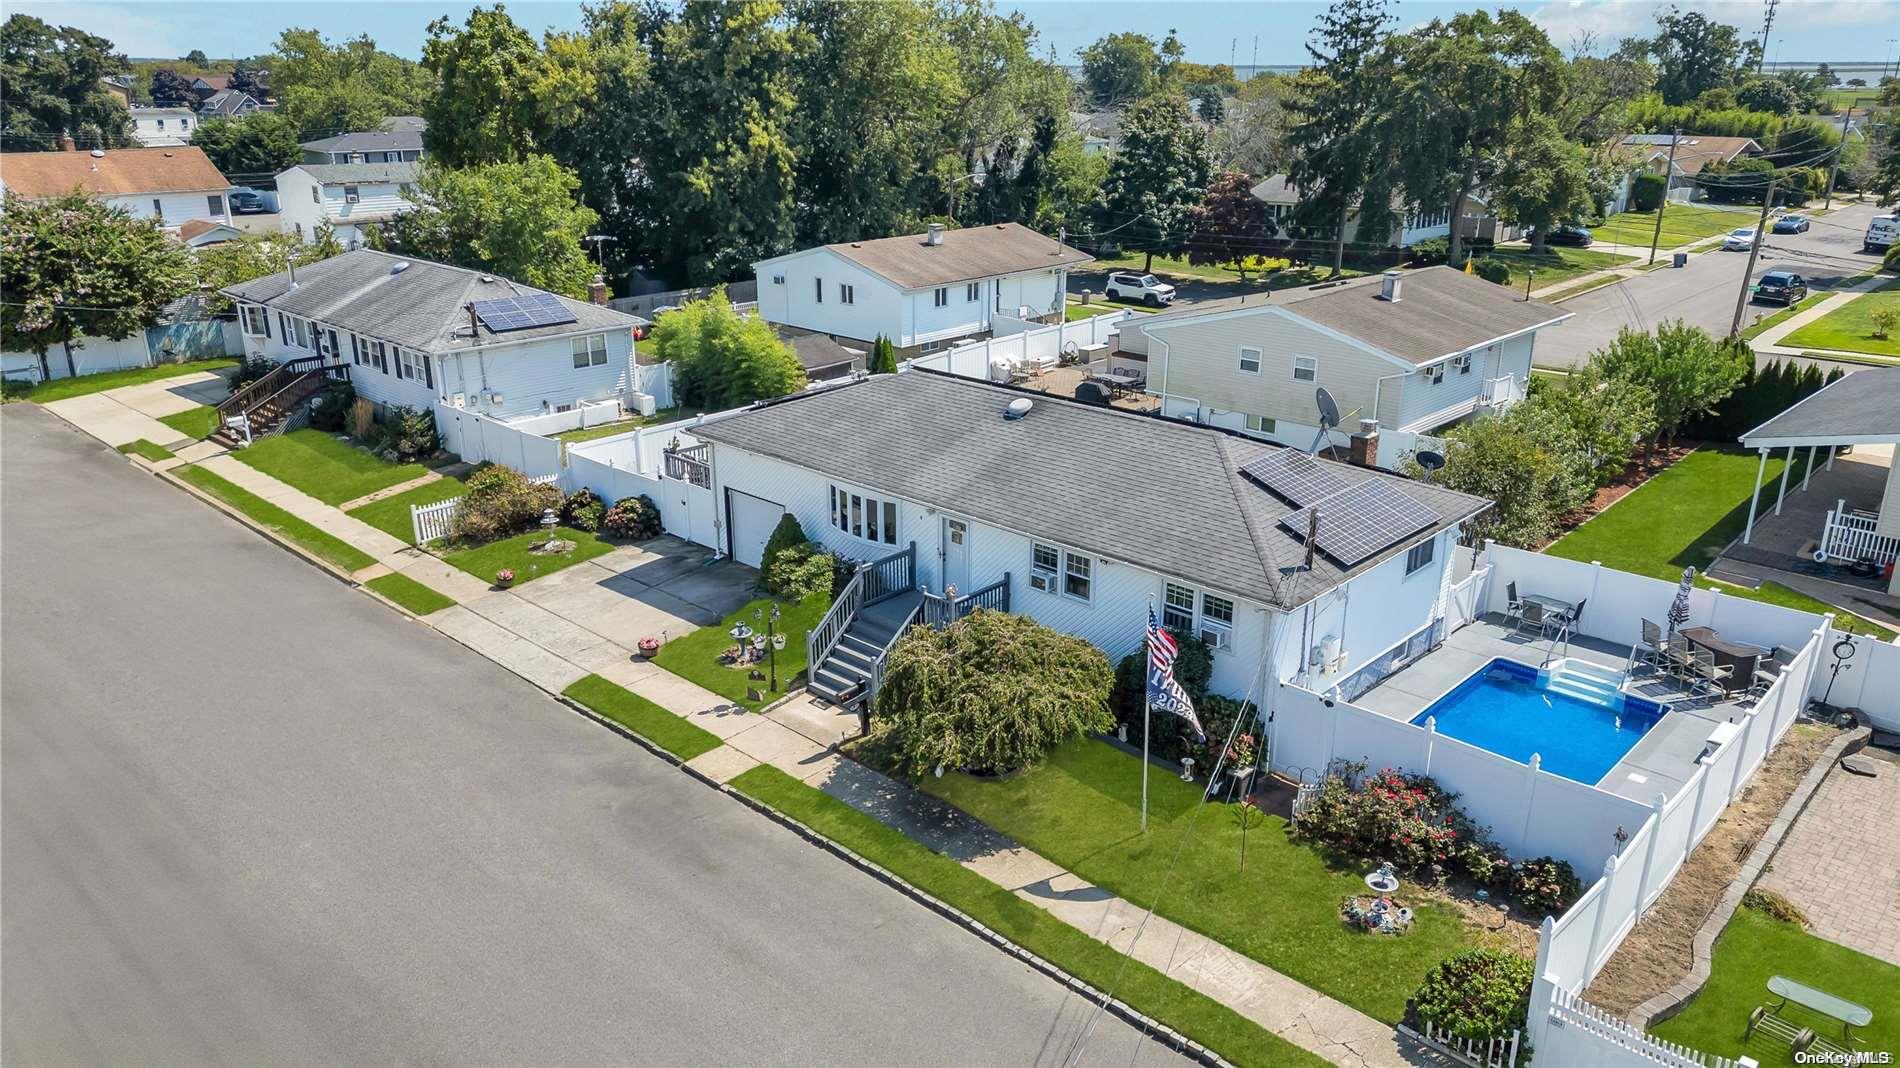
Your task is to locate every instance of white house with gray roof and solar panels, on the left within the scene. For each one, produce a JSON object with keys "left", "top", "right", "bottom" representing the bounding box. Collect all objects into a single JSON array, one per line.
[{"left": 222, "top": 249, "right": 648, "bottom": 429}]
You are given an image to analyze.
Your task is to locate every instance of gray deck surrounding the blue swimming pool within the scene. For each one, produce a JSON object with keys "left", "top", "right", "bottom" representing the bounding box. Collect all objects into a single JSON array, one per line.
[{"left": 1353, "top": 616, "right": 1744, "bottom": 804}]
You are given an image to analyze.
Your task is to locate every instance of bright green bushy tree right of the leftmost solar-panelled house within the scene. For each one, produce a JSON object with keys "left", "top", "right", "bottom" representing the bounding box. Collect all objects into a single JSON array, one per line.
[{"left": 648, "top": 285, "right": 806, "bottom": 410}]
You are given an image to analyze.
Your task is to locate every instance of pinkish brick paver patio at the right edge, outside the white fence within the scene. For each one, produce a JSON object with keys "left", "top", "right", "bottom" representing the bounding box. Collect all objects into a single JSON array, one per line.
[{"left": 1761, "top": 749, "right": 1900, "bottom": 963}]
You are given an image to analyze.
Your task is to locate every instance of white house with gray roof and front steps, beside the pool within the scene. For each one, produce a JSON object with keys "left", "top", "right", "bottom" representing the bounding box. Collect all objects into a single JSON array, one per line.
[{"left": 690, "top": 371, "right": 1490, "bottom": 707}]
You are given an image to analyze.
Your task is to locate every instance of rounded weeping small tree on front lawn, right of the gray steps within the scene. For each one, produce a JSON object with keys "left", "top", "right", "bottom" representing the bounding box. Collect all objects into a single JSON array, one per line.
[{"left": 878, "top": 608, "right": 1115, "bottom": 777}]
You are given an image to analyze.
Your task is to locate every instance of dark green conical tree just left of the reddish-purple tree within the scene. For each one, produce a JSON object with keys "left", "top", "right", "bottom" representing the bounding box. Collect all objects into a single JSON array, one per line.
[{"left": 1102, "top": 95, "right": 1208, "bottom": 270}]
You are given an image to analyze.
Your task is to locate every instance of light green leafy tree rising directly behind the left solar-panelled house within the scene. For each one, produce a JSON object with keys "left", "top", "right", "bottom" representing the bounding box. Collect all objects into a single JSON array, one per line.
[{"left": 376, "top": 156, "right": 597, "bottom": 296}]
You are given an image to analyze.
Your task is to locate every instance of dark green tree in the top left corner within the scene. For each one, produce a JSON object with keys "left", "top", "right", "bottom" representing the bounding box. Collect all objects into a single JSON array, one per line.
[{"left": 0, "top": 13, "right": 131, "bottom": 152}]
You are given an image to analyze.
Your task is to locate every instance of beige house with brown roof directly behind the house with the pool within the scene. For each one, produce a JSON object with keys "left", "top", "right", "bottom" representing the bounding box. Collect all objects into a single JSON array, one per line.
[{"left": 1121, "top": 266, "right": 1571, "bottom": 457}]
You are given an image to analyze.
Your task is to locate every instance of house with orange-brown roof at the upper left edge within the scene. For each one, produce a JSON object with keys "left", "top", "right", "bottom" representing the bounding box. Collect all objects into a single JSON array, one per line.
[{"left": 0, "top": 141, "right": 230, "bottom": 228}]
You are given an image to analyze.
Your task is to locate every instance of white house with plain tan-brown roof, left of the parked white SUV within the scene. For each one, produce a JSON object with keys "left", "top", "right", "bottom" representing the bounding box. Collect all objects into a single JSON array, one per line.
[{"left": 752, "top": 222, "right": 1093, "bottom": 355}]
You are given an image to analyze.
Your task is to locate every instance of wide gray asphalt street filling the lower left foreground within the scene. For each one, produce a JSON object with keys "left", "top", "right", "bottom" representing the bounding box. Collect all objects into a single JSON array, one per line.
[{"left": 0, "top": 405, "right": 1172, "bottom": 1064}]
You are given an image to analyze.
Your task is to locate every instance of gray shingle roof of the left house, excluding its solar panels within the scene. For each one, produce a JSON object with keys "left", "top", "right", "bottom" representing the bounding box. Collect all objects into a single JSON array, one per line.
[{"left": 220, "top": 249, "right": 646, "bottom": 352}]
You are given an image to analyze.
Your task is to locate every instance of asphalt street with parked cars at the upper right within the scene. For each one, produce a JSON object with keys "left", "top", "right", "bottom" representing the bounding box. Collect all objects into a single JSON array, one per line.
[{"left": 1531, "top": 203, "right": 1879, "bottom": 369}]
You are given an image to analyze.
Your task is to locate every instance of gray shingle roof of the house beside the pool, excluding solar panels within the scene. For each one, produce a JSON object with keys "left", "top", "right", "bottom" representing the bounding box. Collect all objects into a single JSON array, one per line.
[{"left": 692, "top": 371, "right": 1490, "bottom": 608}]
